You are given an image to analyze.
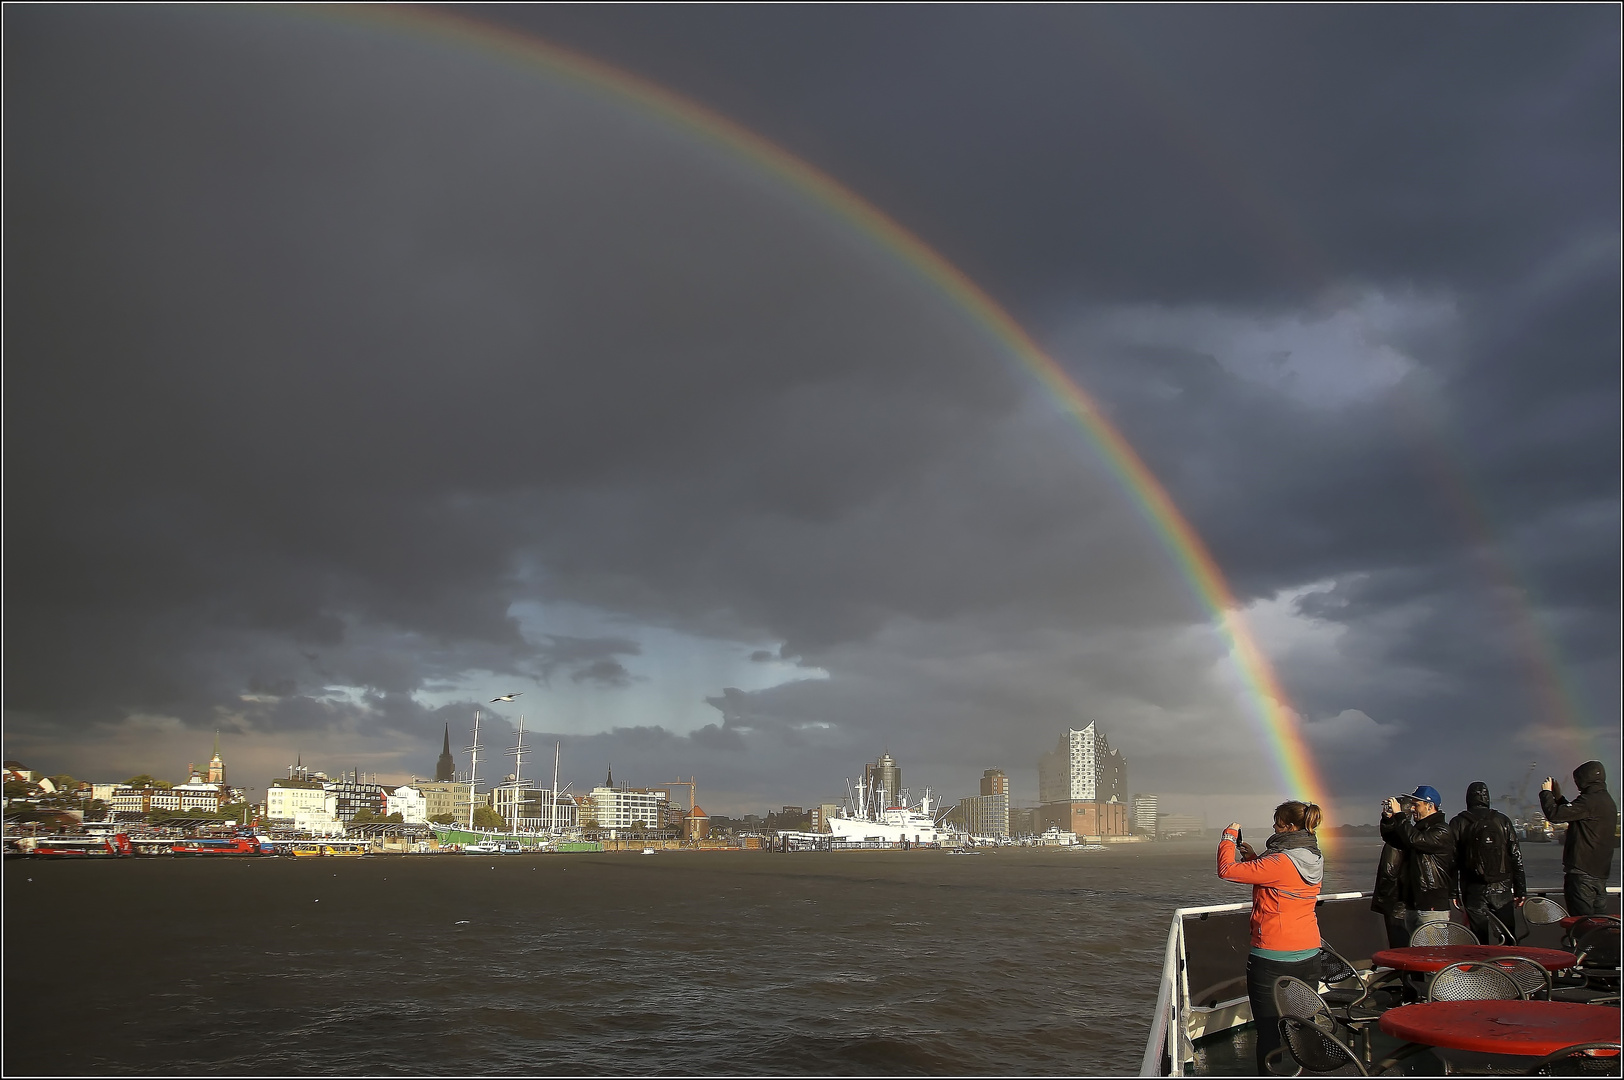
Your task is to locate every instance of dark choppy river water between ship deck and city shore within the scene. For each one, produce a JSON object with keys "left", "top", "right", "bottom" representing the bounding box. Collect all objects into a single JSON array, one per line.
[{"left": 3, "top": 840, "right": 1585, "bottom": 1075}]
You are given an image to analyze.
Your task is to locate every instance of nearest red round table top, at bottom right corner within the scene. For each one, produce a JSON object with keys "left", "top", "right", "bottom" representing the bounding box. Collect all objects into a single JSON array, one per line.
[{"left": 1379, "top": 1002, "right": 1619, "bottom": 1057}]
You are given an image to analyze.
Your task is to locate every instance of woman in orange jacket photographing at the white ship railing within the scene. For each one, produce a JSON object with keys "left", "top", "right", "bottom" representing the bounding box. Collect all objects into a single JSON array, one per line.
[{"left": 1218, "top": 802, "right": 1325, "bottom": 1074}]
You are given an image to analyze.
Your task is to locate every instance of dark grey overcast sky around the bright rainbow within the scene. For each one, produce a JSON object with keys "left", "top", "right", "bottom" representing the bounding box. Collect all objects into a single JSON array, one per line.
[{"left": 5, "top": 5, "right": 1619, "bottom": 822}]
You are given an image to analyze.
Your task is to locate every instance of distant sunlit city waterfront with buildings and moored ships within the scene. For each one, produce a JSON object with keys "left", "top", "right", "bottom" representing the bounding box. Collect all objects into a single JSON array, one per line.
[{"left": 5, "top": 713, "right": 1169, "bottom": 859}]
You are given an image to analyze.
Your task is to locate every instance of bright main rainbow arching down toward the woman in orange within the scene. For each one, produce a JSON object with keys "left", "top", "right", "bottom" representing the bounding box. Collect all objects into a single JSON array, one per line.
[{"left": 284, "top": 6, "right": 1327, "bottom": 804}]
